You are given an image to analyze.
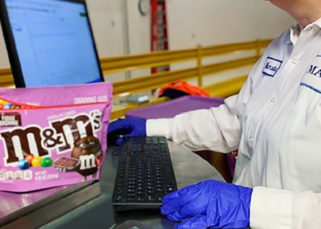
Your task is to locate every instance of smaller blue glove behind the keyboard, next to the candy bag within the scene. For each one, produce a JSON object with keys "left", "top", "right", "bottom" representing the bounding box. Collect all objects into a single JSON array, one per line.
[{"left": 107, "top": 117, "right": 146, "bottom": 145}]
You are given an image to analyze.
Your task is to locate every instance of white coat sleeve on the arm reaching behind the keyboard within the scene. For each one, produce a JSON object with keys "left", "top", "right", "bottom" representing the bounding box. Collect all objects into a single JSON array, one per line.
[{"left": 146, "top": 96, "right": 240, "bottom": 152}]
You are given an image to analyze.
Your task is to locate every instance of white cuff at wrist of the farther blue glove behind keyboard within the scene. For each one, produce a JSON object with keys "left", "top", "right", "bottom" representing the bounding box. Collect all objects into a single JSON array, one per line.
[{"left": 146, "top": 118, "right": 172, "bottom": 139}]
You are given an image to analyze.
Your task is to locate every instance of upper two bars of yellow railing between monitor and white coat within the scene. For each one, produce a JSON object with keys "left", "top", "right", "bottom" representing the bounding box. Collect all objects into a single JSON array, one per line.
[{"left": 101, "top": 40, "right": 271, "bottom": 96}]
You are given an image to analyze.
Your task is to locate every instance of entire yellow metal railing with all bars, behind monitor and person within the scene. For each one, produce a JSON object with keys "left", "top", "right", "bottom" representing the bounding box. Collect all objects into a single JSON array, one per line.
[{"left": 0, "top": 40, "right": 271, "bottom": 118}]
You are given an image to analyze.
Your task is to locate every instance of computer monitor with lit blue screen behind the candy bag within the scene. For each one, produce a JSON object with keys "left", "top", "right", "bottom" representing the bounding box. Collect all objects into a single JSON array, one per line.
[{"left": 0, "top": 0, "right": 103, "bottom": 87}]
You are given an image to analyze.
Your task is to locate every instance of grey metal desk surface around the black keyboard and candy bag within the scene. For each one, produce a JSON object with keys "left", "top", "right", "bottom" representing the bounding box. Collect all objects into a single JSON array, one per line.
[{"left": 3, "top": 142, "right": 224, "bottom": 229}]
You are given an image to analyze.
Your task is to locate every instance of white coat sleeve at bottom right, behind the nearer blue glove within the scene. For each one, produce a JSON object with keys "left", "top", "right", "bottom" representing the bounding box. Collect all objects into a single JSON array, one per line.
[{"left": 250, "top": 187, "right": 321, "bottom": 229}]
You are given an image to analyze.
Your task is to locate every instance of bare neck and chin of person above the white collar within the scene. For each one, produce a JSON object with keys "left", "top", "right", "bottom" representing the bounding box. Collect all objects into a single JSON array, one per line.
[{"left": 289, "top": 4, "right": 321, "bottom": 31}]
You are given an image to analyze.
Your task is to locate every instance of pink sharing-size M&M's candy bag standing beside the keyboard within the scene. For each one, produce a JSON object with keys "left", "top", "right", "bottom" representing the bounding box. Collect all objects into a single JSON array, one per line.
[{"left": 0, "top": 83, "right": 112, "bottom": 192}]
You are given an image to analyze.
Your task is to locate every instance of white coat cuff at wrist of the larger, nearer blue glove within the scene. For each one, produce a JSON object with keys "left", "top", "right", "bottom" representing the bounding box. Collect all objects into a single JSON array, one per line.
[{"left": 250, "top": 187, "right": 293, "bottom": 229}]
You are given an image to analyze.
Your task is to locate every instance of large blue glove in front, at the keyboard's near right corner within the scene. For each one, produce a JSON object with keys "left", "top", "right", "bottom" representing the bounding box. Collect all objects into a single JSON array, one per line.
[{"left": 161, "top": 180, "right": 253, "bottom": 229}]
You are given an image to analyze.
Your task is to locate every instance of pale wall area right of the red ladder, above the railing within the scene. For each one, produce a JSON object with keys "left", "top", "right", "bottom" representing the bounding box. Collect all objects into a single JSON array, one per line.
[{"left": 167, "top": 0, "right": 293, "bottom": 49}]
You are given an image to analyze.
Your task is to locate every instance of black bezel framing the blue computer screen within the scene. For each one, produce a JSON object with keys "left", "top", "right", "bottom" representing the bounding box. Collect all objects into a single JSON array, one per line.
[{"left": 0, "top": 0, "right": 104, "bottom": 88}]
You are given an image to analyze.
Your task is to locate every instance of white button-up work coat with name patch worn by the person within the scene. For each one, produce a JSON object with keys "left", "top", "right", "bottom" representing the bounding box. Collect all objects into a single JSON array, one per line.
[{"left": 147, "top": 19, "right": 321, "bottom": 229}]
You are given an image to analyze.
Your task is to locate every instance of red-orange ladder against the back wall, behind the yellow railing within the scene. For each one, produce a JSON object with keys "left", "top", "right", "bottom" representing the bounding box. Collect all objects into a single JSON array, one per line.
[{"left": 151, "top": 0, "right": 169, "bottom": 73}]
